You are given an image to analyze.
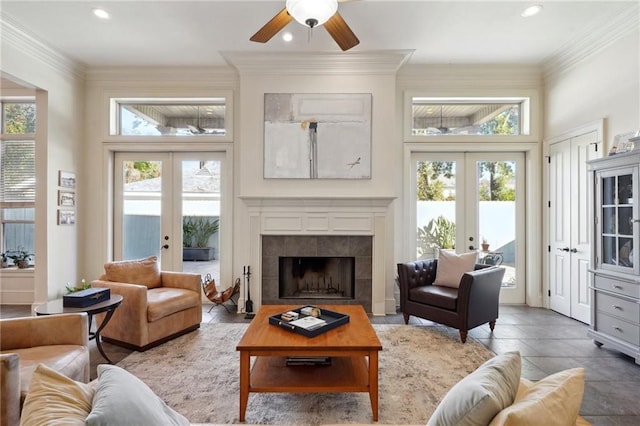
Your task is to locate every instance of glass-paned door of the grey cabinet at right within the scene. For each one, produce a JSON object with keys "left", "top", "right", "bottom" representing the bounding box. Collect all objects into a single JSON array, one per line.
[{"left": 601, "top": 172, "right": 635, "bottom": 268}]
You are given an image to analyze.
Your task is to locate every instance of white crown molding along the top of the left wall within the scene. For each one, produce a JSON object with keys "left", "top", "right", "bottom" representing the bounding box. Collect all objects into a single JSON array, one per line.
[{"left": 0, "top": 11, "right": 85, "bottom": 79}]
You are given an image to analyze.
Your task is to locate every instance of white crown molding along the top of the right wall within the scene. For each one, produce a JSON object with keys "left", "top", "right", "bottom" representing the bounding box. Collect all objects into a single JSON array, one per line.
[{"left": 541, "top": 2, "right": 640, "bottom": 79}]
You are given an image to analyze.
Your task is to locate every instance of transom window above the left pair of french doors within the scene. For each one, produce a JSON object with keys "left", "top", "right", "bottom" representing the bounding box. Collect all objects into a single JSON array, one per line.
[{"left": 111, "top": 97, "right": 228, "bottom": 136}]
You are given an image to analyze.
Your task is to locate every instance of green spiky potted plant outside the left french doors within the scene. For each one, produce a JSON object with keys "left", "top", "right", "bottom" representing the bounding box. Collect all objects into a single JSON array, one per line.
[{"left": 182, "top": 217, "right": 220, "bottom": 260}]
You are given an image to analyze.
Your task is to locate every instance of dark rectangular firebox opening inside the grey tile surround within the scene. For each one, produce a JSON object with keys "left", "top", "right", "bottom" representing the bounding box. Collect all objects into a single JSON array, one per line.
[{"left": 278, "top": 256, "right": 356, "bottom": 299}]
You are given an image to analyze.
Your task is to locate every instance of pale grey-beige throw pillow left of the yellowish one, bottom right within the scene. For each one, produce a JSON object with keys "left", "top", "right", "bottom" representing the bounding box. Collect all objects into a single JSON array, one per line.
[{"left": 427, "top": 352, "right": 521, "bottom": 426}]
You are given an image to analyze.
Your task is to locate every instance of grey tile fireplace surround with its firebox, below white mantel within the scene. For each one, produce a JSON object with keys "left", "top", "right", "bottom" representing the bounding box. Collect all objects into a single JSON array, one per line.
[{"left": 262, "top": 235, "right": 373, "bottom": 312}]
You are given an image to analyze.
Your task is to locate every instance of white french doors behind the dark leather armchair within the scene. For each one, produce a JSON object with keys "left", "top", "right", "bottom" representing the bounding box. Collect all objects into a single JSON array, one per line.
[{"left": 411, "top": 152, "right": 525, "bottom": 304}]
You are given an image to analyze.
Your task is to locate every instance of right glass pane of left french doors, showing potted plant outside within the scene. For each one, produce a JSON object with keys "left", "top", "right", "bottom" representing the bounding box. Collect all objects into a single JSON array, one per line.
[{"left": 182, "top": 160, "right": 221, "bottom": 284}]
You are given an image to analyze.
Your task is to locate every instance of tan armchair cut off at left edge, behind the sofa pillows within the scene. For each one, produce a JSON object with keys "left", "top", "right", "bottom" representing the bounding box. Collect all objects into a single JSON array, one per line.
[{"left": 0, "top": 313, "right": 90, "bottom": 425}]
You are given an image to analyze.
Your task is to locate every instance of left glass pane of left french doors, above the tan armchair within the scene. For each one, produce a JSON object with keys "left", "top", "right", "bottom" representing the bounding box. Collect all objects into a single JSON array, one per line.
[{"left": 122, "top": 161, "right": 162, "bottom": 260}]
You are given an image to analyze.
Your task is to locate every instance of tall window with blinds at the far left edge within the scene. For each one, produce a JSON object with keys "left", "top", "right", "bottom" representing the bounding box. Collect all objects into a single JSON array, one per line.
[{"left": 0, "top": 100, "right": 36, "bottom": 266}]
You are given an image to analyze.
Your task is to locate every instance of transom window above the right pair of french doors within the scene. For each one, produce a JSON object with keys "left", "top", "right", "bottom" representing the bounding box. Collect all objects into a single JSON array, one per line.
[{"left": 411, "top": 96, "right": 529, "bottom": 136}]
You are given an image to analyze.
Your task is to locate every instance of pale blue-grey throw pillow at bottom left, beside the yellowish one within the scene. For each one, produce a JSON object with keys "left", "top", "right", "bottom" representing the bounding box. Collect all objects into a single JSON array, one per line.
[{"left": 86, "top": 364, "right": 189, "bottom": 426}]
